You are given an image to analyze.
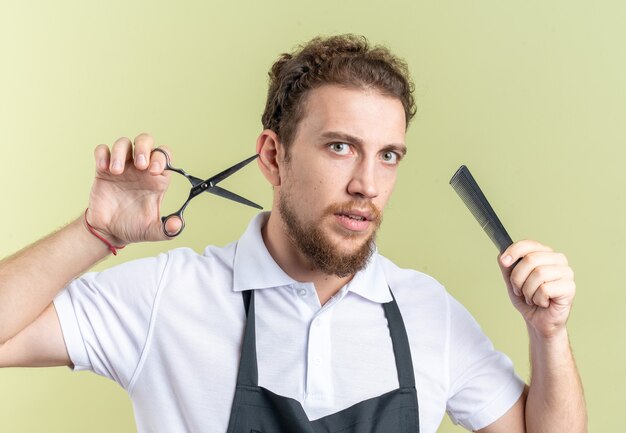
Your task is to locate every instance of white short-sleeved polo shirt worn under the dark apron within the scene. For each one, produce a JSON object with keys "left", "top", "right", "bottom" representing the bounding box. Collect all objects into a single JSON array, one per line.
[{"left": 54, "top": 214, "right": 524, "bottom": 433}]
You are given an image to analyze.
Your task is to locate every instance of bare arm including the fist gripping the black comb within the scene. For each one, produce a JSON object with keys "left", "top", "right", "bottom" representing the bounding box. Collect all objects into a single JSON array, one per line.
[{"left": 480, "top": 241, "right": 587, "bottom": 433}]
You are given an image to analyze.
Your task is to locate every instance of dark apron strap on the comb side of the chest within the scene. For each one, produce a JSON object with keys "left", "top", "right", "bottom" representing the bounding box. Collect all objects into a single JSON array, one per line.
[{"left": 383, "top": 289, "right": 415, "bottom": 388}]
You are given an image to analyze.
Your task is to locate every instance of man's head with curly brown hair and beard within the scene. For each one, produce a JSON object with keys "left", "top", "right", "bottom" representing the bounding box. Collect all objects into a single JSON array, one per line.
[{"left": 257, "top": 36, "right": 415, "bottom": 277}]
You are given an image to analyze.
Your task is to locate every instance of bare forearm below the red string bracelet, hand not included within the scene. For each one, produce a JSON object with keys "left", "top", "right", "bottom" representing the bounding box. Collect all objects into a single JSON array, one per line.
[{"left": 0, "top": 217, "right": 109, "bottom": 344}]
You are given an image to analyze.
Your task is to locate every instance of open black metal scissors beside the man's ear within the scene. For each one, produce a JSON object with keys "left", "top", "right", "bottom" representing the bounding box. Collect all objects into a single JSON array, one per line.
[{"left": 152, "top": 147, "right": 263, "bottom": 238}]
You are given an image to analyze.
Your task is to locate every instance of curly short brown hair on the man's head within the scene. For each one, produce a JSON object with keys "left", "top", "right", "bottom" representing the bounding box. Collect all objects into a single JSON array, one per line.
[{"left": 261, "top": 34, "right": 416, "bottom": 149}]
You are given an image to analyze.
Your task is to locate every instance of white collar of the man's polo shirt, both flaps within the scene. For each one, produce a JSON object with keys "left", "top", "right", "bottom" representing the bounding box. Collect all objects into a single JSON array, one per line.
[{"left": 233, "top": 212, "right": 392, "bottom": 303}]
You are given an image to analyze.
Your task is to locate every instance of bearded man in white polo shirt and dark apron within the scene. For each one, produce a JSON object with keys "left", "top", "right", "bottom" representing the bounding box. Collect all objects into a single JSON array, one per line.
[{"left": 0, "top": 35, "right": 586, "bottom": 433}]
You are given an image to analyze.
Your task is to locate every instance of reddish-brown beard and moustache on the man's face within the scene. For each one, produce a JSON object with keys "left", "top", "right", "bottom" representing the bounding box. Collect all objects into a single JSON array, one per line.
[{"left": 278, "top": 191, "right": 382, "bottom": 278}]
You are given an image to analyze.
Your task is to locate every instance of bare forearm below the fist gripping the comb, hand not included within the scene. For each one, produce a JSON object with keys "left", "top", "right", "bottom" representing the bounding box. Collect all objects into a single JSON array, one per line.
[{"left": 526, "top": 326, "right": 587, "bottom": 433}]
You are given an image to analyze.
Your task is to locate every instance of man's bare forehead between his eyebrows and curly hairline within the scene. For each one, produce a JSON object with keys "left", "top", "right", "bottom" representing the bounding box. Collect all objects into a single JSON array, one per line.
[{"left": 295, "top": 85, "right": 406, "bottom": 144}]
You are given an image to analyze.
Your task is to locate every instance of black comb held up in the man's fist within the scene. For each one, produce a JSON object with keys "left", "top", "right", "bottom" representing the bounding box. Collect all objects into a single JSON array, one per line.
[{"left": 450, "top": 165, "right": 513, "bottom": 253}]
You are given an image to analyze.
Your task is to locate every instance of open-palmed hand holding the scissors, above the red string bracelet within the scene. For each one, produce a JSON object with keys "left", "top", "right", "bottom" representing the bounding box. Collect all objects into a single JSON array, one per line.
[{"left": 86, "top": 134, "right": 182, "bottom": 246}]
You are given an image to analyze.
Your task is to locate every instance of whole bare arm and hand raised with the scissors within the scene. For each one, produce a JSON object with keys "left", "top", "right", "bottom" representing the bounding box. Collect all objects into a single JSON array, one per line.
[{"left": 0, "top": 134, "right": 180, "bottom": 366}]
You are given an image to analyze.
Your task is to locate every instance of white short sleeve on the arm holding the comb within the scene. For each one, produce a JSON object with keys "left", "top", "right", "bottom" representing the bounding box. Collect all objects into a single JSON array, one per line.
[{"left": 447, "top": 297, "right": 525, "bottom": 430}]
